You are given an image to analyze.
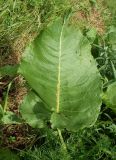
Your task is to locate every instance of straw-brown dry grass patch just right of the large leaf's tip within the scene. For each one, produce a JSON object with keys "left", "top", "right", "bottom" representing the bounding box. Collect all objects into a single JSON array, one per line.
[{"left": 71, "top": 1, "right": 106, "bottom": 35}]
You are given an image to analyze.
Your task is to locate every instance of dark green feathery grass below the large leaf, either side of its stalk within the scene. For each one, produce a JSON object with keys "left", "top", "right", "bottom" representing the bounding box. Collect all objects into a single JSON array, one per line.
[{"left": 20, "top": 121, "right": 116, "bottom": 160}]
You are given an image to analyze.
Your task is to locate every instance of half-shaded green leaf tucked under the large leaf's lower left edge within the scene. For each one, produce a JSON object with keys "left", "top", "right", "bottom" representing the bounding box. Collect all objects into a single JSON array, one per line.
[{"left": 20, "top": 91, "right": 50, "bottom": 128}]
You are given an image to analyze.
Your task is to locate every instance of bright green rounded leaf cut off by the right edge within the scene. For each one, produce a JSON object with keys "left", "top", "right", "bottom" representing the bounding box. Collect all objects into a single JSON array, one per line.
[{"left": 103, "top": 82, "right": 116, "bottom": 112}]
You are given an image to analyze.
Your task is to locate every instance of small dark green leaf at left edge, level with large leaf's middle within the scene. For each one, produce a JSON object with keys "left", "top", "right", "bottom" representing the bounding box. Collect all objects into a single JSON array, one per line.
[{"left": 0, "top": 65, "right": 19, "bottom": 76}]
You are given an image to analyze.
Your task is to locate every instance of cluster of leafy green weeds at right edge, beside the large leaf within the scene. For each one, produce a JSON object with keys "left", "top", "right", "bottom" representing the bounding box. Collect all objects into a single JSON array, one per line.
[{"left": 92, "top": 25, "right": 116, "bottom": 80}]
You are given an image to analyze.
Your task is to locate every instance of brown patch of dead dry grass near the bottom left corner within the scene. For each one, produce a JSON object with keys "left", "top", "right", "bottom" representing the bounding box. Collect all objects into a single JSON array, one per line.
[{"left": 1, "top": 124, "right": 36, "bottom": 149}]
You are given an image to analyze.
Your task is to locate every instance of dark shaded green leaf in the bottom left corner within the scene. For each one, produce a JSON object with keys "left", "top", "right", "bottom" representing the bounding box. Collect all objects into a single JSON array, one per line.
[{"left": 0, "top": 149, "right": 19, "bottom": 160}]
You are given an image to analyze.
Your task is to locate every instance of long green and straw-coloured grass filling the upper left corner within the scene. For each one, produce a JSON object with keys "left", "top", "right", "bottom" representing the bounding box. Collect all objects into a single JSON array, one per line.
[{"left": 0, "top": 0, "right": 70, "bottom": 65}]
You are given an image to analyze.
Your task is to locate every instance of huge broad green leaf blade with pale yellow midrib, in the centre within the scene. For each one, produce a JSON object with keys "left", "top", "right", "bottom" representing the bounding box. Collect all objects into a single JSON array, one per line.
[{"left": 19, "top": 20, "right": 102, "bottom": 130}]
